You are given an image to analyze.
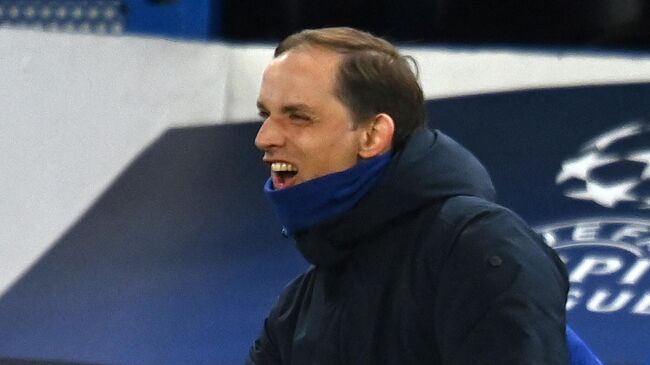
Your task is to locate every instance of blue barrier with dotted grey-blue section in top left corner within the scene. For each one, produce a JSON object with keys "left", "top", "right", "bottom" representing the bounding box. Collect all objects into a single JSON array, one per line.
[{"left": 0, "top": 0, "right": 221, "bottom": 40}]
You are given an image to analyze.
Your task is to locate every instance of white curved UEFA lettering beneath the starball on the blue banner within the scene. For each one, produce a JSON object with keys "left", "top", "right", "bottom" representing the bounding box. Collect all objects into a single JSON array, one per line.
[{"left": 536, "top": 217, "right": 650, "bottom": 316}]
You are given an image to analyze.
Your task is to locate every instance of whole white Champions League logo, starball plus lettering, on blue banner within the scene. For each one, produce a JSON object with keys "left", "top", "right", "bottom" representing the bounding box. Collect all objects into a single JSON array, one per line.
[{"left": 536, "top": 122, "right": 650, "bottom": 316}]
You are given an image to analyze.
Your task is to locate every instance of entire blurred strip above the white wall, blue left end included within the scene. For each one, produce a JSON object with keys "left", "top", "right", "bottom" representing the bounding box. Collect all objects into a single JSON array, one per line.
[{"left": 0, "top": 0, "right": 650, "bottom": 49}]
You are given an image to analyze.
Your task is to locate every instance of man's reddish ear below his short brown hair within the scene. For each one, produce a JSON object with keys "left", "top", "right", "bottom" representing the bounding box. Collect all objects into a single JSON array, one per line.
[{"left": 359, "top": 113, "right": 395, "bottom": 159}]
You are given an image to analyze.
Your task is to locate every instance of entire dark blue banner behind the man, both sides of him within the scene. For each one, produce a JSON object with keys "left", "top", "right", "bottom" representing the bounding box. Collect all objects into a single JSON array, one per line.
[{"left": 0, "top": 83, "right": 650, "bottom": 365}]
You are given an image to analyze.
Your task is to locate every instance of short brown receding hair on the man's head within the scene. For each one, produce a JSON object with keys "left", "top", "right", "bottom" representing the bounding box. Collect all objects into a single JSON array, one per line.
[{"left": 274, "top": 27, "right": 425, "bottom": 150}]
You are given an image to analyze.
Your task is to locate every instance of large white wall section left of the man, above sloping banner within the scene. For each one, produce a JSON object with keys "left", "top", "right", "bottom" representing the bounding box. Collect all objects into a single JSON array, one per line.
[{"left": 0, "top": 29, "right": 229, "bottom": 293}]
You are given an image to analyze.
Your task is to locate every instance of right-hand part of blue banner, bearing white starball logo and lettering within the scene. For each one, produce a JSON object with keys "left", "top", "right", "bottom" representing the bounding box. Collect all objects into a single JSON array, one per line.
[{"left": 428, "top": 84, "right": 650, "bottom": 365}]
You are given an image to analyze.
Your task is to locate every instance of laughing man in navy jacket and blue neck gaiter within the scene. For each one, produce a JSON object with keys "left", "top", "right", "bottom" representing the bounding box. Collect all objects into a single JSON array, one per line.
[{"left": 247, "top": 28, "right": 569, "bottom": 365}]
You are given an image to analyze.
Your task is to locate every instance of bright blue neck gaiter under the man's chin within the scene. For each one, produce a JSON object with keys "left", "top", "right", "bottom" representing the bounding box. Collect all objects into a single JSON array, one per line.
[{"left": 264, "top": 153, "right": 392, "bottom": 236}]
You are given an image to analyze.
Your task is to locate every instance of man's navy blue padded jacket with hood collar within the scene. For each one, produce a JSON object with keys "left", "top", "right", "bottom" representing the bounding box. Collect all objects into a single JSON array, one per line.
[{"left": 246, "top": 129, "right": 569, "bottom": 365}]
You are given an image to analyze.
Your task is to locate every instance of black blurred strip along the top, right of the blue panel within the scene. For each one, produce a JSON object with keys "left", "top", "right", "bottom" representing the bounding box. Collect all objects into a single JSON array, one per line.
[{"left": 222, "top": 0, "right": 650, "bottom": 48}]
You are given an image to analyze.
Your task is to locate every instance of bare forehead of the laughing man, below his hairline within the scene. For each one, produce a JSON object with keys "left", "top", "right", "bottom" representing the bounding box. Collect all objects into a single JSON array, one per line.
[{"left": 260, "top": 47, "right": 341, "bottom": 101}]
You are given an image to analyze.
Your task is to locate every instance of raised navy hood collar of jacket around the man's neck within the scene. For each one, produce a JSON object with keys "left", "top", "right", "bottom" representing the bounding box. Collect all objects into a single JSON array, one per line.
[{"left": 295, "top": 128, "right": 495, "bottom": 266}]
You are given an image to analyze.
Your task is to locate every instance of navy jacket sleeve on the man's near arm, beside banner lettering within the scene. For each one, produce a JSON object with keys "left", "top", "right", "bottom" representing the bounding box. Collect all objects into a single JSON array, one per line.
[{"left": 434, "top": 208, "right": 569, "bottom": 365}]
